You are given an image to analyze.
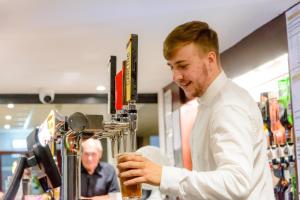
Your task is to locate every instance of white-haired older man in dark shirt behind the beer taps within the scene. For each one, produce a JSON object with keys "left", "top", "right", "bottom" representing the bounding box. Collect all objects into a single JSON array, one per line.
[{"left": 81, "top": 138, "right": 120, "bottom": 199}]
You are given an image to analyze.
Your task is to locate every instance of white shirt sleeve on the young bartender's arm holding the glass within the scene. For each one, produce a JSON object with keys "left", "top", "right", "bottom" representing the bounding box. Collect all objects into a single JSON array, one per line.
[{"left": 160, "top": 106, "right": 254, "bottom": 199}]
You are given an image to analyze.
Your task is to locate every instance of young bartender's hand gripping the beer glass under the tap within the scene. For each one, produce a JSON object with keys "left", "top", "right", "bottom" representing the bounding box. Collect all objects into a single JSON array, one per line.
[{"left": 117, "top": 154, "right": 162, "bottom": 186}]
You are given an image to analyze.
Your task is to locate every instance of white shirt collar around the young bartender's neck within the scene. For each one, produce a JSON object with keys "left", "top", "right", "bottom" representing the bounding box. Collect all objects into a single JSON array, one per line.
[{"left": 198, "top": 70, "right": 228, "bottom": 105}]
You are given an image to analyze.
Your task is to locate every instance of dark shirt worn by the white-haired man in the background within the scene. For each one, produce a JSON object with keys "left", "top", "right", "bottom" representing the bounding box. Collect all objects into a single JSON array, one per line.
[{"left": 81, "top": 162, "right": 120, "bottom": 197}]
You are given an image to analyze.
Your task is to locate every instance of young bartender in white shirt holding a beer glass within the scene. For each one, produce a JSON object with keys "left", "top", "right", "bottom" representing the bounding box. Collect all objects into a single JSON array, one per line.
[{"left": 118, "top": 21, "right": 274, "bottom": 200}]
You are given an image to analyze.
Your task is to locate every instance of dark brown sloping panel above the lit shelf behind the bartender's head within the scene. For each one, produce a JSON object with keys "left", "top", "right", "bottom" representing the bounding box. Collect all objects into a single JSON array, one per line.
[{"left": 221, "top": 14, "right": 288, "bottom": 78}]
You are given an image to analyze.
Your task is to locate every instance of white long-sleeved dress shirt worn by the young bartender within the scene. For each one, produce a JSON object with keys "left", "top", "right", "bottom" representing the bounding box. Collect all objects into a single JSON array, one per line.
[{"left": 160, "top": 72, "right": 274, "bottom": 200}]
